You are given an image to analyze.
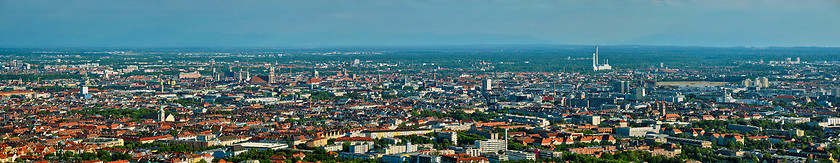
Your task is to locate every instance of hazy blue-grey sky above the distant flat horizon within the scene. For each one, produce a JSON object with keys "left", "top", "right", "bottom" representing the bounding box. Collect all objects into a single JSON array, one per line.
[{"left": 0, "top": 0, "right": 840, "bottom": 47}]
